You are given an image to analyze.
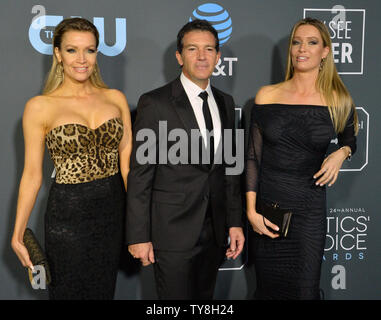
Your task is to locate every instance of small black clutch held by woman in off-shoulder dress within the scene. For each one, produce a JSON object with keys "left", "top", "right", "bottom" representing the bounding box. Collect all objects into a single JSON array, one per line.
[{"left": 256, "top": 199, "right": 292, "bottom": 237}]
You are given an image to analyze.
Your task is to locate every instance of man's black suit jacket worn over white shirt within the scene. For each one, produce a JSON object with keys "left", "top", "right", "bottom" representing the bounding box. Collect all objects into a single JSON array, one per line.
[{"left": 126, "top": 78, "right": 242, "bottom": 251}]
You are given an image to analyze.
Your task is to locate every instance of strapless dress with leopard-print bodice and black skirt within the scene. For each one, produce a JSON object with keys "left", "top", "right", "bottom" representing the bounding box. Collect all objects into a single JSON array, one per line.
[{"left": 45, "top": 118, "right": 125, "bottom": 300}]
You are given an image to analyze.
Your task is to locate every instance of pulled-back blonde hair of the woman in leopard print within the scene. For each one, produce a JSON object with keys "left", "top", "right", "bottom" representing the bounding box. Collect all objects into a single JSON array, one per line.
[{"left": 43, "top": 18, "right": 108, "bottom": 94}]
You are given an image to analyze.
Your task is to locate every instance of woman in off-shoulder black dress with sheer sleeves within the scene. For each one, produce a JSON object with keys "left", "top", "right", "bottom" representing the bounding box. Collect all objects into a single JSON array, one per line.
[{"left": 246, "top": 18, "right": 358, "bottom": 299}]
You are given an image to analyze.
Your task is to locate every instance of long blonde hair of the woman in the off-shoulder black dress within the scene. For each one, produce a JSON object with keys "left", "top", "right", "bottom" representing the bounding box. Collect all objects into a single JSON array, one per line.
[{"left": 285, "top": 18, "right": 358, "bottom": 135}]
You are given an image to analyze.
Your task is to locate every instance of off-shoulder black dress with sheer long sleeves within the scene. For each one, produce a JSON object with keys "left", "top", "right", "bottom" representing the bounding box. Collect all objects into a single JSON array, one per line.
[{"left": 246, "top": 104, "right": 356, "bottom": 300}]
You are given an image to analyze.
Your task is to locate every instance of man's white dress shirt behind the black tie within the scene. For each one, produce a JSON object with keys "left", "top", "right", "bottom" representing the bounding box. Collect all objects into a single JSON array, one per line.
[{"left": 180, "top": 73, "right": 221, "bottom": 153}]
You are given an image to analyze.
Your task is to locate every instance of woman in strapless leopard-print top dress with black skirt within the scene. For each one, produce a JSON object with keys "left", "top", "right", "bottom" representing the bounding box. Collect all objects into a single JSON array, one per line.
[{"left": 12, "top": 18, "right": 132, "bottom": 299}]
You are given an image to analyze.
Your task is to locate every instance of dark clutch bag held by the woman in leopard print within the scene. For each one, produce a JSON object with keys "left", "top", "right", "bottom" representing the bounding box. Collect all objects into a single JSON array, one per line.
[{"left": 23, "top": 228, "right": 51, "bottom": 285}]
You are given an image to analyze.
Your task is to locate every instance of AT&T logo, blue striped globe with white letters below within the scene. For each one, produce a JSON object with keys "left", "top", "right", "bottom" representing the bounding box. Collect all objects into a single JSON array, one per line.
[{"left": 189, "top": 3, "right": 238, "bottom": 76}]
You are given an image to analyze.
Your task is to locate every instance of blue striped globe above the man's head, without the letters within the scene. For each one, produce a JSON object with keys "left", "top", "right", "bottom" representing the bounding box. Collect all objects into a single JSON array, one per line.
[{"left": 189, "top": 3, "right": 233, "bottom": 46}]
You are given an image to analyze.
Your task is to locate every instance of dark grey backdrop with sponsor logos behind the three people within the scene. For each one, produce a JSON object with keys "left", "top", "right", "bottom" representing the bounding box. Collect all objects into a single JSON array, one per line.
[{"left": 0, "top": 0, "right": 381, "bottom": 300}]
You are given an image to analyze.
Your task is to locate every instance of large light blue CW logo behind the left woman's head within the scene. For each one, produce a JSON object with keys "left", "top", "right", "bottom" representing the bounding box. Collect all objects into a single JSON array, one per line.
[{"left": 29, "top": 15, "right": 127, "bottom": 56}]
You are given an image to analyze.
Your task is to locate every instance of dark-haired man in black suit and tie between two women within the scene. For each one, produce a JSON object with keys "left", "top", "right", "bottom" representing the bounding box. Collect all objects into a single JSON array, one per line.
[{"left": 126, "top": 20, "right": 245, "bottom": 299}]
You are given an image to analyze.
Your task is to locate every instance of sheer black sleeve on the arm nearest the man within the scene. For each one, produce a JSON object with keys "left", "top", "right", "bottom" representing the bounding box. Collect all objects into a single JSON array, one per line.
[{"left": 246, "top": 105, "right": 262, "bottom": 192}]
